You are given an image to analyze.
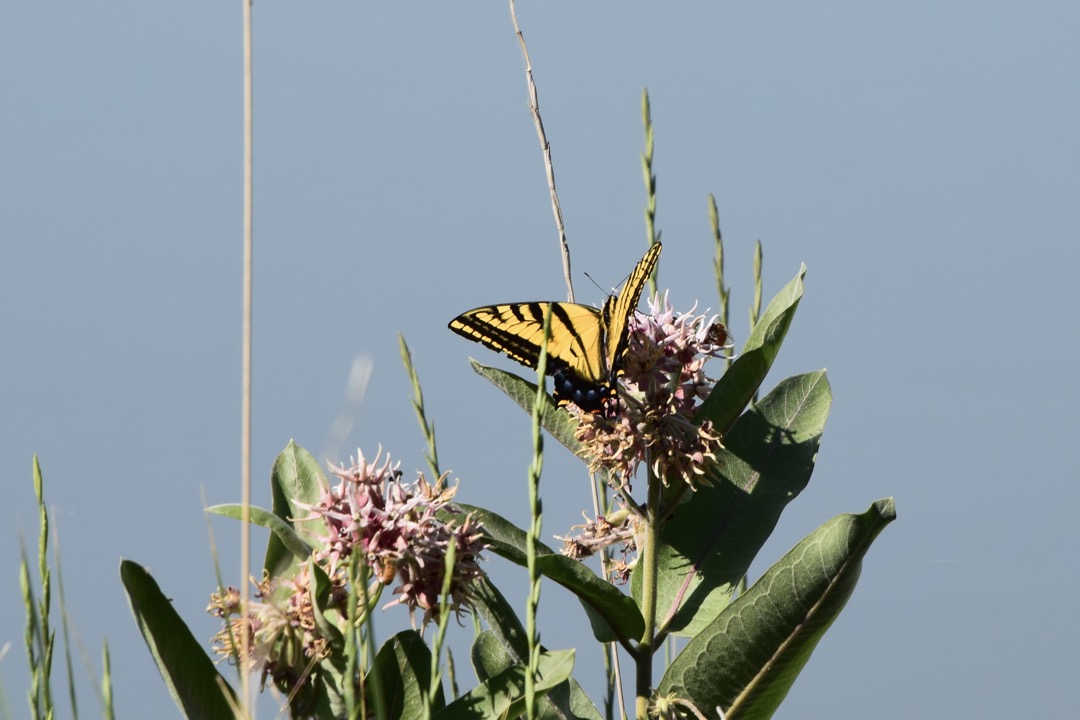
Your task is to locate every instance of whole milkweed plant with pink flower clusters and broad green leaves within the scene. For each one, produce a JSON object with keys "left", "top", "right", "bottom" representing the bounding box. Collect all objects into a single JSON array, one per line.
[{"left": 109, "top": 97, "right": 895, "bottom": 720}]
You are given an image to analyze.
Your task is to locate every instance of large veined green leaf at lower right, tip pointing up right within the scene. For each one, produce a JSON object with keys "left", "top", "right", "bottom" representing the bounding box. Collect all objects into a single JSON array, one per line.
[{"left": 657, "top": 499, "right": 896, "bottom": 720}]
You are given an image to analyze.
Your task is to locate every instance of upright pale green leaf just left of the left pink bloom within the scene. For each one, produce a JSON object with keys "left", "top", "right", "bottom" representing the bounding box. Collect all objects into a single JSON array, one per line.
[{"left": 262, "top": 440, "right": 326, "bottom": 578}]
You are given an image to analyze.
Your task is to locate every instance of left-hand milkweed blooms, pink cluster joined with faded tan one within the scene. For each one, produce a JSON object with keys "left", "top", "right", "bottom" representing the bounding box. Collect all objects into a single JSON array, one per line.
[{"left": 207, "top": 452, "right": 485, "bottom": 691}]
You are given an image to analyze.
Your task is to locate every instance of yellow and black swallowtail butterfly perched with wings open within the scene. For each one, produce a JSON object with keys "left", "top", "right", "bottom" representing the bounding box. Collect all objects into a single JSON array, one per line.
[{"left": 449, "top": 244, "right": 661, "bottom": 411}]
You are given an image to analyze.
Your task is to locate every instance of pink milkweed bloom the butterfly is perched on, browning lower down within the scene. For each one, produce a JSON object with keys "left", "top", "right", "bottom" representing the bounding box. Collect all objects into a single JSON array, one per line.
[{"left": 576, "top": 294, "right": 731, "bottom": 488}]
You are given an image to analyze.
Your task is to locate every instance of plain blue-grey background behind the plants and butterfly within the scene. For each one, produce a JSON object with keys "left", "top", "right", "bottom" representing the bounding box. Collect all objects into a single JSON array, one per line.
[{"left": 0, "top": 1, "right": 1080, "bottom": 720}]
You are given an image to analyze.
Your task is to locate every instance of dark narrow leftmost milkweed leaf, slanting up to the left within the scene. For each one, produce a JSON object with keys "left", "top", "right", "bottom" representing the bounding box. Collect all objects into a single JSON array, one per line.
[{"left": 120, "top": 560, "right": 237, "bottom": 719}]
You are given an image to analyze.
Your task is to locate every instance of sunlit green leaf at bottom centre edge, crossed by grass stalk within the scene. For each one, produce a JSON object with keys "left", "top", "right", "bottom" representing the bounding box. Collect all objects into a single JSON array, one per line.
[{"left": 434, "top": 650, "right": 575, "bottom": 720}]
